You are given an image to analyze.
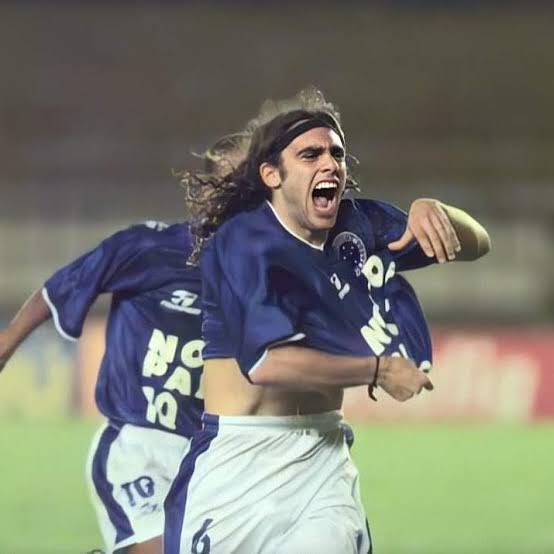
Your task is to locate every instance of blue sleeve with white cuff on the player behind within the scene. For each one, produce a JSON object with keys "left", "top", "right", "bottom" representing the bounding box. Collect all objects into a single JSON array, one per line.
[{"left": 42, "top": 225, "right": 171, "bottom": 340}]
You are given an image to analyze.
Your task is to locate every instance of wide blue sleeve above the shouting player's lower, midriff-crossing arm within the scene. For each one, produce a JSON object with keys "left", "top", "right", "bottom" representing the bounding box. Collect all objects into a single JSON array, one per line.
[{"left": 201, "top": 229, "right": 308, "bottom": 379}]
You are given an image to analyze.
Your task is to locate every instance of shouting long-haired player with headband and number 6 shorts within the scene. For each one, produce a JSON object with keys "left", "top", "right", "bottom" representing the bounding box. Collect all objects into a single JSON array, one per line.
[{"left": 164, "top": 96, "right": 488, "bottom": 554}]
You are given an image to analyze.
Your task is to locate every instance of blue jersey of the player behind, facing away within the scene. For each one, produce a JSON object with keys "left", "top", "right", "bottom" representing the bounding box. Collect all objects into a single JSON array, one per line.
[{"left": 43, "top": 223, "right": 204, "bottom": 437}]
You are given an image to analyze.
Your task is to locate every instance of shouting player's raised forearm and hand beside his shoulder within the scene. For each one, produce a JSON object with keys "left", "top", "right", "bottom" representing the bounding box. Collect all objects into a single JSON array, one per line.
[{"left": 388, "top": 198, "right": 491, "bottom": 263}]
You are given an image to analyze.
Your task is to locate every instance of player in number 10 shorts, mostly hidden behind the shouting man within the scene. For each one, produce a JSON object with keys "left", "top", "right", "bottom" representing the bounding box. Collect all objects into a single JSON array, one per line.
[{"left": 0, "top": 136, "right": 243, "bottom": 554}]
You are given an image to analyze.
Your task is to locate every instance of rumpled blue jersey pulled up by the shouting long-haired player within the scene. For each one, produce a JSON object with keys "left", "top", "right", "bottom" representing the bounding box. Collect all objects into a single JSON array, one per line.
[{"left": 201, "top": 200, "right": 431, "bottom": 377}]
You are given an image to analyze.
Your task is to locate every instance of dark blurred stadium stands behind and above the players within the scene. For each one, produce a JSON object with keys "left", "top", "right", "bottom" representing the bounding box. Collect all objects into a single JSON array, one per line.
[{"left": 0, "top": 0, "right": 554, "bottom": 324}]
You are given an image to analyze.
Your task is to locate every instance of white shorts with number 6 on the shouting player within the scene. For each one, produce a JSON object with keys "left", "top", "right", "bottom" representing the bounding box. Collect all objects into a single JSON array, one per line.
[{"left": 164, "top": 412, "right": 371, "bottom": 554}]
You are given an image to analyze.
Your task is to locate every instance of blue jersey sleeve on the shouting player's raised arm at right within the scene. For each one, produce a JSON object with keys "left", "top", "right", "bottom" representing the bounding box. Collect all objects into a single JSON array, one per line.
[{"left": 353, "top": 198, "right": 436, "bottom": 271}]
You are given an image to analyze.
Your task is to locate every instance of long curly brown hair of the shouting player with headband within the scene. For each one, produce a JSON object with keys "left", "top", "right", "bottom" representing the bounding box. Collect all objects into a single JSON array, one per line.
[{"left": 179, "top": 88, "right": 356, "bottom": 263}]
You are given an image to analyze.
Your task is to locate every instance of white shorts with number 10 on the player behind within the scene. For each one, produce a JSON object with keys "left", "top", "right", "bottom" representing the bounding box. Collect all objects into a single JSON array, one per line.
[{"left": 86, "top": 424, "right": 190, "bottom": 553}]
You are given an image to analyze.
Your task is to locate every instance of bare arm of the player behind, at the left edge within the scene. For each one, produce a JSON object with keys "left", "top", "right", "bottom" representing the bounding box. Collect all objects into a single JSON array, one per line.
[{"left": 0, "top": 290, "right": 51, "bottom": 371}]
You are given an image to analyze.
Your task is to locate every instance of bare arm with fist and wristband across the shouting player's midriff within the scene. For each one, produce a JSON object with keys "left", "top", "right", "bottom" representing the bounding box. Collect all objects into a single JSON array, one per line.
[{"left": 250, "top": 345, "right": 433, "bottom": 401}]
